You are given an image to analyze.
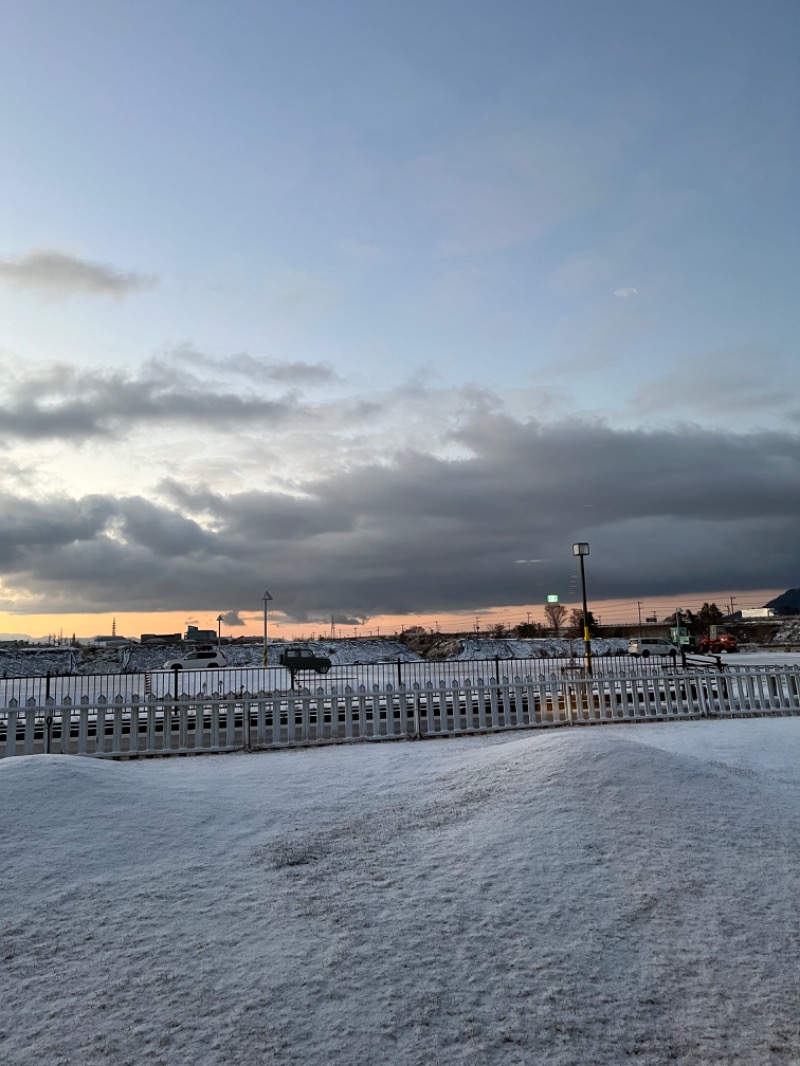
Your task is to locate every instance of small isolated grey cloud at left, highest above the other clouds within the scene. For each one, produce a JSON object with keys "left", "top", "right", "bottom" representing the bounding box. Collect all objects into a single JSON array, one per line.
[{"left": 0, "top": 249, "right": 156, "bottom": 298}]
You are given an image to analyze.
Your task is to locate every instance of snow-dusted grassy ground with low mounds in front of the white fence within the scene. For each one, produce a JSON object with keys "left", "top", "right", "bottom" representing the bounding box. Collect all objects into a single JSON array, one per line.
[{"left": 0, "top": 718, "right": 800, "bottom": 1066}]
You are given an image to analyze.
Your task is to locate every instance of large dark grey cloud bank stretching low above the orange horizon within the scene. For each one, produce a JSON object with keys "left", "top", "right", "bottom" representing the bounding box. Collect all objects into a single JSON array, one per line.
[{"left": 0, "top": 413, "right": 800, "bottom": 620}]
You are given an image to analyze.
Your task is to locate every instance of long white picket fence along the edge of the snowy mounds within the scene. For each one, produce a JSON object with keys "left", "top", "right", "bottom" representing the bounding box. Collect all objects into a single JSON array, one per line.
[{"left": 0, "top": 666, "right": 800, "bottom": 758}]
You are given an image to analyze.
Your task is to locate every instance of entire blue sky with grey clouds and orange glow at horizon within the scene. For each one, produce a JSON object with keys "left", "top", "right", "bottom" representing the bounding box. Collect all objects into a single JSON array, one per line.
[{"left": 0, "top": 0, "right": 800, "bottom": 634}]
